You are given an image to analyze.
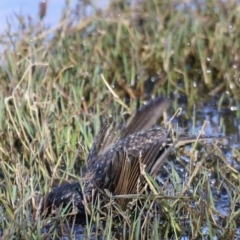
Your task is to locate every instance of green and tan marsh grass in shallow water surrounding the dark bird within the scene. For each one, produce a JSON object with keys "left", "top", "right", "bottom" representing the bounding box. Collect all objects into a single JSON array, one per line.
[{"left": 0, "top": 0, "right": 240, "bottom": 239}]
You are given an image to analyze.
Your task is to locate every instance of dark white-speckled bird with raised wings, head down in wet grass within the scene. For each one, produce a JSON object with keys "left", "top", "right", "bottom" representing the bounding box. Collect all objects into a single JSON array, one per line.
[{"left": 42, "top": 96, "right": 223, "bottom": 223}]
